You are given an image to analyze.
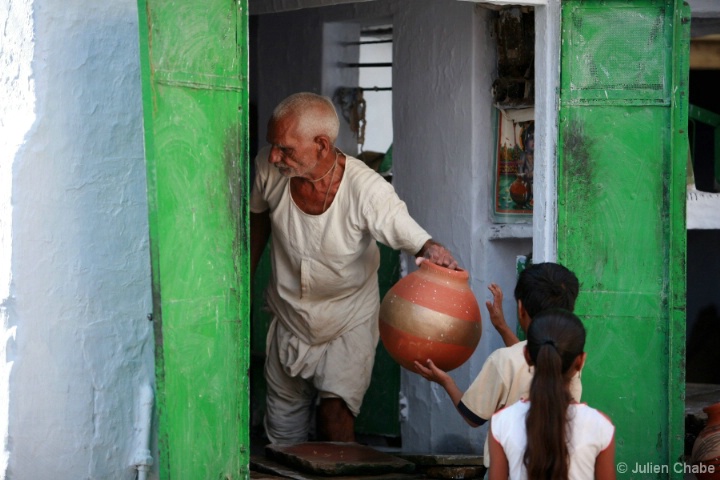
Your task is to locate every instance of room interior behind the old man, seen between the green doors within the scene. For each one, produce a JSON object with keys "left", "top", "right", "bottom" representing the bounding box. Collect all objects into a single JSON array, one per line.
[{"left": 250, "top": 0, "right": 534, "bottom": 462}]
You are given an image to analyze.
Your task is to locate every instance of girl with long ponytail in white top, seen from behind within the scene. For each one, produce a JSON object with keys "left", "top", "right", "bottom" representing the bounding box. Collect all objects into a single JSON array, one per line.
[{"left": 489, "top": 310, "right": 615, "bottom": 480}]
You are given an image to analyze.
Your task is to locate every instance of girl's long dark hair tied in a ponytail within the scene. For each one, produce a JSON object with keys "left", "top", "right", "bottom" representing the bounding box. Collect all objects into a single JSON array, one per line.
[{"left": 524, "top": 310, "right": 585, "bottom": 480}]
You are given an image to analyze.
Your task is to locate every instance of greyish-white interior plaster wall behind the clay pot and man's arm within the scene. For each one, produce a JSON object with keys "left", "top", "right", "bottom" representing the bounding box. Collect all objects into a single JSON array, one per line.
[{"left": 393, "top": 0, "right": 531, "bottom": 453}]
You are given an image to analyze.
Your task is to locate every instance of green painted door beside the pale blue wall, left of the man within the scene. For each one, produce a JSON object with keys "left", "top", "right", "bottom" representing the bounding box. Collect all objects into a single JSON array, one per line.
[{"left": 138, "top": 0, "right": 250, "bottom": 480}]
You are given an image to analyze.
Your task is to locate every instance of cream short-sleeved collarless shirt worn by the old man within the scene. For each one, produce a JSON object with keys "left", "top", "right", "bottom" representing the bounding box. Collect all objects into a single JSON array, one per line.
[{"left": 250, "top": 148, "right": 430, "bottom": 344}]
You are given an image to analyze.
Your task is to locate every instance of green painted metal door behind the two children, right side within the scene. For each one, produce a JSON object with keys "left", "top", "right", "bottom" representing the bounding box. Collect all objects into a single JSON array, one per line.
[{"left": 558, "top": 0, "right": 689, "bottom": 479}]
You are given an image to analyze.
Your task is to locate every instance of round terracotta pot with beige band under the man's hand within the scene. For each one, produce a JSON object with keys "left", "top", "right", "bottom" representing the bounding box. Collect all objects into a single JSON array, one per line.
[{"left": 380, "top": 261, "right": 482, "bottom": 371}]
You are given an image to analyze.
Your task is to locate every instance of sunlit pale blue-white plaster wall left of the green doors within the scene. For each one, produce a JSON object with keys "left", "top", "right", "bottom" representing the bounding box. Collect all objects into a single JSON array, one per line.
[{"left": 0, "top": 0, "right": 154, "bottom": 480}]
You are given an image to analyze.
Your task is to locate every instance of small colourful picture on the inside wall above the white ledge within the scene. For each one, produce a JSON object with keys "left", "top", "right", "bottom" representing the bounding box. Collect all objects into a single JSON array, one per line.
[{"left": 493, "top": 108, "right": 535, "bottom": 223}]
